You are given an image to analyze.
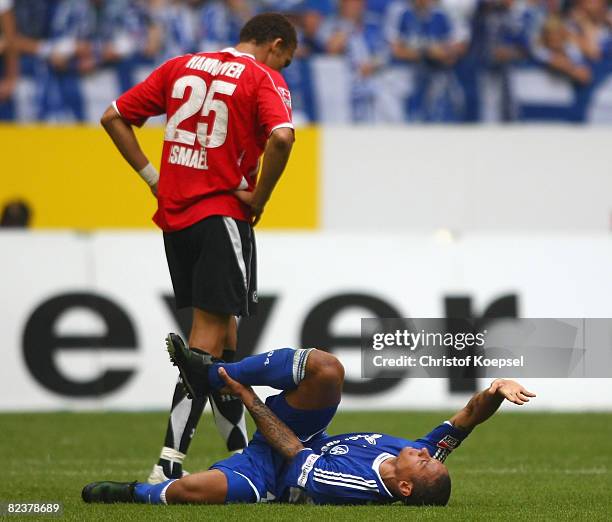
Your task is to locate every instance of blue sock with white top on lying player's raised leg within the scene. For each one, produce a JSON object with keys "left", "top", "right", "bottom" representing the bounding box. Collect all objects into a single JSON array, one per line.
[{"left": 208, "top": 348, "right": 310, "bottom": 390}]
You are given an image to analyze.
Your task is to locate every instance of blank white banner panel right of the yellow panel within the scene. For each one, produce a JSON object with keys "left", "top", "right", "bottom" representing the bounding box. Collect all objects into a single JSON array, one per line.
[{"left": 321, "top": 125, "right": 612, "bottom": 234}]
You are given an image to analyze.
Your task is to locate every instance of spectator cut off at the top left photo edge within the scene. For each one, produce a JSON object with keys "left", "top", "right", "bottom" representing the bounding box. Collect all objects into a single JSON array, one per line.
[{"left": 0, "top": 0, "right": 19, "bottom": 120}]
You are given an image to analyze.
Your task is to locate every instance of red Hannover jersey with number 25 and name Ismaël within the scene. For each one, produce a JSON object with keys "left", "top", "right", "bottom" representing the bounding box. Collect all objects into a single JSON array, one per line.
[{"left": 114, "top": 48, "right": 293, "bottom": 232}]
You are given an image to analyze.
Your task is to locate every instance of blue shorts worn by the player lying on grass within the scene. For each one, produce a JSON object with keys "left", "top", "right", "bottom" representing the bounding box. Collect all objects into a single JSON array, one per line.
[{"left": 210, "top": 392, "right": 338, "bottom": 503}]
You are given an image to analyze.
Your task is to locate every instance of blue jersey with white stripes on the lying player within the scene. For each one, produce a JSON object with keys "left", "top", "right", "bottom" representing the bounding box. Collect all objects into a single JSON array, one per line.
[{"left": 279, "top": 421, "right": 469, "bottom": 504}]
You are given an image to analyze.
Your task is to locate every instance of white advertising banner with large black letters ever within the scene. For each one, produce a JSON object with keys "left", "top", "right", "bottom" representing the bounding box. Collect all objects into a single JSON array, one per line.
[{"left": 0, "top": 232, "right": 612, "bottom": 411}]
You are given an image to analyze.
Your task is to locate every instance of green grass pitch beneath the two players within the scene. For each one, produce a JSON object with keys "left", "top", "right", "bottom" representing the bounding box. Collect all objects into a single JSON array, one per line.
[{"left": 0, "top": 412, "right": 612, "bottom": 522}]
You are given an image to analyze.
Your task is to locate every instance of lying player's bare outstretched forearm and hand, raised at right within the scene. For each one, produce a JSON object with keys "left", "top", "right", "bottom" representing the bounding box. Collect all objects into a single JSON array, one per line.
[{"left": 450, "top": 379, "right": 535, "bottom": 431}]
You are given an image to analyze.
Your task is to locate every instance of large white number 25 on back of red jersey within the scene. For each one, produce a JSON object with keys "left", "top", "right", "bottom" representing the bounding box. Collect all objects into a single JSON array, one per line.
[{"left": 164, "top": 76, "right": 236, "bottom": 149}]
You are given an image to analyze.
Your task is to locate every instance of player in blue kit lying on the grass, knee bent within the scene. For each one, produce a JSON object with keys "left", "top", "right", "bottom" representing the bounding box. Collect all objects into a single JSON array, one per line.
[{"left": 82, "top": 334, "right": 535, "bottom": 505}]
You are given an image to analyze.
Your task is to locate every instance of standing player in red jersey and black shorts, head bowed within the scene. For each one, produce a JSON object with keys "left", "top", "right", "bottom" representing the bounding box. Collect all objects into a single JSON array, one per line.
[{"left": 101, "top": 13, "right": 297, "bottom": 483}]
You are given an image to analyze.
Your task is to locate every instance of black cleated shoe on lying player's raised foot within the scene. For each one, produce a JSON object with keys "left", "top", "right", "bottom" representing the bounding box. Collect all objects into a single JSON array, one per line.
[{"left": 166, "top": 333, "right": 222, "bottom": 399}]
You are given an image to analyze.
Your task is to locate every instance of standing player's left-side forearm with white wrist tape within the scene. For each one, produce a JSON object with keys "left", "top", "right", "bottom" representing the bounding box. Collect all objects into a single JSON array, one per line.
[{"left": 100, "top": 105, "right": 159, "bottom": 195}]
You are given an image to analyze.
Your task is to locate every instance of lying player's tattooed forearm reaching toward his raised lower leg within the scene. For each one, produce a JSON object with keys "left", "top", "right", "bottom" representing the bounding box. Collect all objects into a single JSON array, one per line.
[{"left": 219, "top": 368, "right": 304, "bottom": 460}]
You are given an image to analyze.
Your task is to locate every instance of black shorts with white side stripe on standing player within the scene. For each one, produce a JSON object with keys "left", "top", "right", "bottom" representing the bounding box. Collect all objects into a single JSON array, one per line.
[{"left": 164, "top": 216, "right": 257, "bottom": 317}]
